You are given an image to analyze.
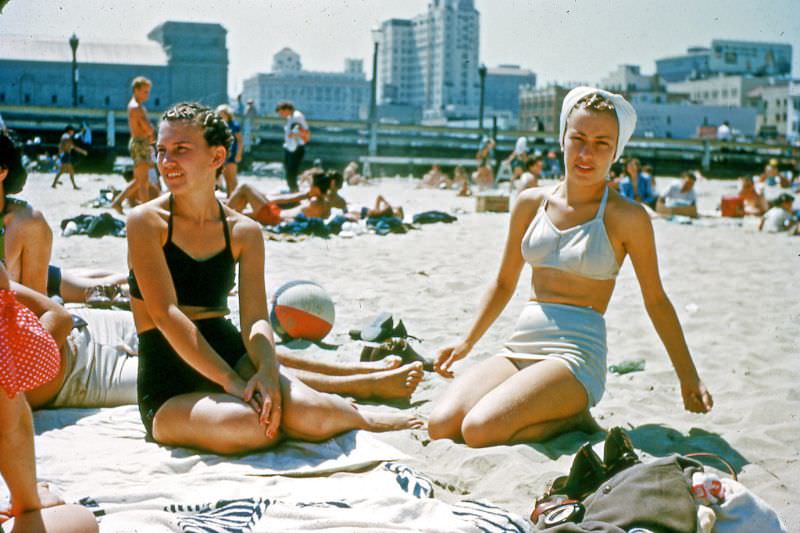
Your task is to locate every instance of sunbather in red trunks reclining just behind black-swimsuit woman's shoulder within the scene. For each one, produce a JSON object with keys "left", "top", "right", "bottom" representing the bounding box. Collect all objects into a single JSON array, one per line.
[{"left": 228, "top": 171, "right": 338, "bottom": 226}]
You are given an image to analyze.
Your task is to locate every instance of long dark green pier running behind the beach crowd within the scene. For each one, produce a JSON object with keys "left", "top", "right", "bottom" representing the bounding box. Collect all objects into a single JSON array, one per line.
[{"left": 0, "top": 106, "right": 792, "bottom": 177}]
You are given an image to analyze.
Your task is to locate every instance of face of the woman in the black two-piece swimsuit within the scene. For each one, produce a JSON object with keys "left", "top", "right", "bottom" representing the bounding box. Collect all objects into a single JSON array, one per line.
[{"left": 156, "top": 121, "right": 225, "bottom": 193}]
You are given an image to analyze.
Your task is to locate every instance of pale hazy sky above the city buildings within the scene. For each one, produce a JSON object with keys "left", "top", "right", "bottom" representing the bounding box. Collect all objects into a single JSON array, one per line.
[{"left": 0, "top": 0, "right": 800, "bottom": 95}]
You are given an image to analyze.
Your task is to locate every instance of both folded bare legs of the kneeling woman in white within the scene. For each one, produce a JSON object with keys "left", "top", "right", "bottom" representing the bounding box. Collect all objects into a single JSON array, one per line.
[{"left": 428, "top": 357, "right": 599, "bottom": 448}]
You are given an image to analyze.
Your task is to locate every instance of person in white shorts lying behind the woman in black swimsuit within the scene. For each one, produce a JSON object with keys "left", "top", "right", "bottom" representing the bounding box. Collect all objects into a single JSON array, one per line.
[{"left": 11, "top": 282, "right": 422, "bottom": 409}]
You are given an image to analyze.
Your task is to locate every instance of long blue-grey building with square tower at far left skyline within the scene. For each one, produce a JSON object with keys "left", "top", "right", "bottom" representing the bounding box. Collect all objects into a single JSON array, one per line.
[{"left": 0, "top": 21, "right": 228, "bottom": 109}]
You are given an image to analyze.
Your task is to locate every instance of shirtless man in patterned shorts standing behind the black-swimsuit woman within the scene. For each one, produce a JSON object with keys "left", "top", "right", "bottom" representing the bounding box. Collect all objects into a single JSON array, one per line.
[{"left": 111, "top": 76, "right": 154, "bottom": 214}]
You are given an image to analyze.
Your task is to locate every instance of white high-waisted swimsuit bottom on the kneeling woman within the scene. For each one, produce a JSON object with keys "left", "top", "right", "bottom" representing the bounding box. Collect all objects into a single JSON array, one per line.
[{"left": 498, "top": 301, "right": 608, "bottom": 406}]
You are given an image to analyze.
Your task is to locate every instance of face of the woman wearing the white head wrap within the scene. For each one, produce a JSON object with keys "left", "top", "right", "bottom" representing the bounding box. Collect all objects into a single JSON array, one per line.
[{"left": 564, "top": 109, "right": 618, "bottom": 182}]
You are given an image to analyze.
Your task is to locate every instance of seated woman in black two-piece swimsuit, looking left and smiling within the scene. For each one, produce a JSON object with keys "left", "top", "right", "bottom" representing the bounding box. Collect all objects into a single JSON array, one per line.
[{"left": 127, "top": 103, "right": 422, "bottom": 454}]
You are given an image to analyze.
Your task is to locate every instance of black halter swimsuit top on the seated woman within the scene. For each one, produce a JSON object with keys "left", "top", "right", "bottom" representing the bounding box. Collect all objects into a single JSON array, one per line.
[{"left": 128, "top": 195, "right": 236, "bottom": 307}]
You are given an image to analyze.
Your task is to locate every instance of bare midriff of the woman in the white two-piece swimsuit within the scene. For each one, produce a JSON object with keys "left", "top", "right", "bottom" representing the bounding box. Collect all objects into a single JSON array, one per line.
[{"left": 530, "top": 267, "right": 615, "bottom": 314}]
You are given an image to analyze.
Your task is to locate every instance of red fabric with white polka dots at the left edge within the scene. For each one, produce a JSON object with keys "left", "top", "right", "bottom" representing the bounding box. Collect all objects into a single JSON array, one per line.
[{"left": 0, "top": 289, "right": 61, "bottom": 398}]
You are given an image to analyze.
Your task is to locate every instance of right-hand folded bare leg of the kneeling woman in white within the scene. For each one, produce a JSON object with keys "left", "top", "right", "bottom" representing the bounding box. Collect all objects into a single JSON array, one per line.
[{"left": 461, "top": 360, "right": 600, "bottom": 447}]
